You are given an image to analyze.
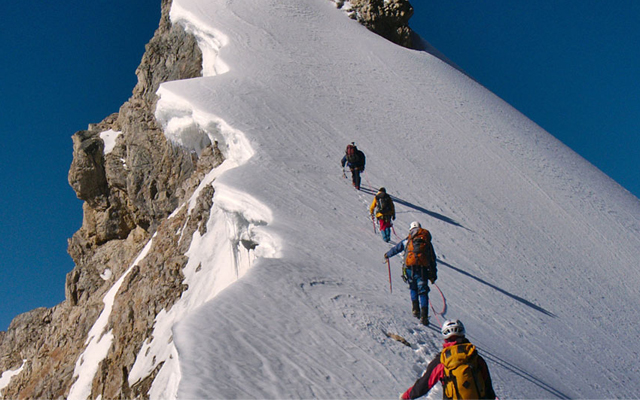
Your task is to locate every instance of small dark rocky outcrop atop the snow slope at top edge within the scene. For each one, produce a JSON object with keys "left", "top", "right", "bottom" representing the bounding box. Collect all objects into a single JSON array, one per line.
[{"left": 335, "top": 0, "right": 420, "bottom": 49}]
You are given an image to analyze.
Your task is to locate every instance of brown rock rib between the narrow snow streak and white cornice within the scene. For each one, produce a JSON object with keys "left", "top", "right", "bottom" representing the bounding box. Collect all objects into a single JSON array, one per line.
[{"left": 92, "top": 180, "right": 220, "bottom": 398}]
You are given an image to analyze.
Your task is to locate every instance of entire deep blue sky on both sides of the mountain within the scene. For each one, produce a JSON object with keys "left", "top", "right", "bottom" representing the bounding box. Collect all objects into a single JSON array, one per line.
[{"left": 0, "top": 0, "right": 640, "bottom": 330}]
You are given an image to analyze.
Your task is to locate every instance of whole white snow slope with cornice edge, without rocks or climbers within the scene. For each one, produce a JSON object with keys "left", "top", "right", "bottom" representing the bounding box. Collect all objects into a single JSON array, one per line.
[{"left": 66, "top": 0, "right": 640, "bottom": 398}]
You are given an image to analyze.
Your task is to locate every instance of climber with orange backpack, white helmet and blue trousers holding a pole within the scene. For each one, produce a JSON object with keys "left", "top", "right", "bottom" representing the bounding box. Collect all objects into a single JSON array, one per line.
[{"left": 384, "top": 221, "right": 438, "bottom": 325}]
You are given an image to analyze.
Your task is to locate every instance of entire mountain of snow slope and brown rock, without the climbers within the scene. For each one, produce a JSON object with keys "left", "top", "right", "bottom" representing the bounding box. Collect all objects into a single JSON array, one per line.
[{"left": 0, "top": 0, "right": 640, "bottom": 398}]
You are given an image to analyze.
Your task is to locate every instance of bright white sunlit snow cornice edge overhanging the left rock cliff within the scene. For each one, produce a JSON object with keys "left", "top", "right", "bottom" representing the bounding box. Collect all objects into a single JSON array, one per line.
[{"left": 129, "top": 14, "right": 281, "bottom": 390}]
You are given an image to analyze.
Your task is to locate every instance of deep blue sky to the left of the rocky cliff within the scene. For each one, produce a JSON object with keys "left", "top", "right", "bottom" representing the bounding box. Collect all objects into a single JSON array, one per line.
[{"left": 0, "top": 0, "right": 160, "bottom": 330}]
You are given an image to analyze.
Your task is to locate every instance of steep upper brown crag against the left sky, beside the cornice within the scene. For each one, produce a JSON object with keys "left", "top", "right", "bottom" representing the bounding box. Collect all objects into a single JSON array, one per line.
[{"left": 69, "top": 0, "right": 202, "bottom": 256}]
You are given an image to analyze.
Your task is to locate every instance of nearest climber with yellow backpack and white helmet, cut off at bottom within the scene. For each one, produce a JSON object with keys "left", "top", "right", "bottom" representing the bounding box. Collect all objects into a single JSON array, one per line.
[{"left": 400, "top": 320, "right": 496, "bottom": 400}]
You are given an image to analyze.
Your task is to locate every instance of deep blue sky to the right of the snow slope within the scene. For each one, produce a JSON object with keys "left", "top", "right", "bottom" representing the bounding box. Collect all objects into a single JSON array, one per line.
[{"left": 411, "top": 0, "right": 640, "bottom": 197}]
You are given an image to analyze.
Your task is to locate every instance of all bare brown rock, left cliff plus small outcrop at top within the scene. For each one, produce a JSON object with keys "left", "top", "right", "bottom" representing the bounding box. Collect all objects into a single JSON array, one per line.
[{"left": 0, "top": 0, "right": 412, "bottom": 399}]
